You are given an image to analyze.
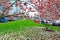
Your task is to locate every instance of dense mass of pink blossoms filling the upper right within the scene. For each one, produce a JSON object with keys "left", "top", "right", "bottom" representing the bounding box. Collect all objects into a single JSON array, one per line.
[{"left": 30, "top": 0, "right": 60, "bottom": 20}]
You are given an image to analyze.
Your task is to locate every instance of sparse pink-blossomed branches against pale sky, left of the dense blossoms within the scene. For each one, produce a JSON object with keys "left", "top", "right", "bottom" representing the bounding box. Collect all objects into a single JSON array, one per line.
[{"left": 2, "top": 0, "right": 38, "bottom": 17}]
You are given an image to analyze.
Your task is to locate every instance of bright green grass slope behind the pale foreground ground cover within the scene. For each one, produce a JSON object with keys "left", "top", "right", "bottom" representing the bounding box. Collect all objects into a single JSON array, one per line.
[{"left": 0, "top": 20, "right": 60, "bottom": 32}]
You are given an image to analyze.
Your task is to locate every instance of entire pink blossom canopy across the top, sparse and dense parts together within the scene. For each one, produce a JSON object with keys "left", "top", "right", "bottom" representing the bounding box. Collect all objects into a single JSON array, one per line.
[{"left": 2, "top": 0, "right": 60, "bottom": 20}]
